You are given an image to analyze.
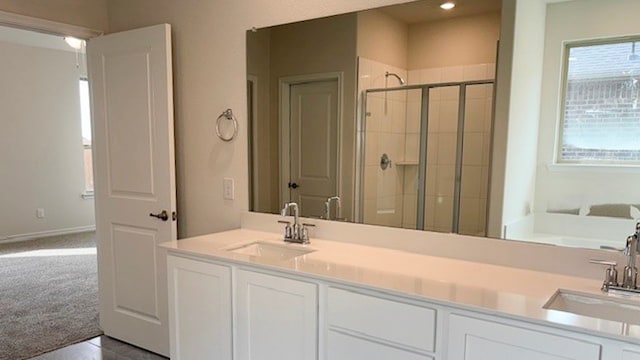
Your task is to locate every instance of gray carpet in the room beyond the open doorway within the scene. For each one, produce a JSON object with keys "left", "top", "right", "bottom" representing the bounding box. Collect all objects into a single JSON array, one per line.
[{"left": 0, "top": 232, "right": 102, "bottom": 360}]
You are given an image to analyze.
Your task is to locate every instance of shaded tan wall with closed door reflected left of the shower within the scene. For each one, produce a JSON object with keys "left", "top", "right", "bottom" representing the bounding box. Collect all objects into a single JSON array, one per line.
[{"left": 247, "top": 14, "right": 357, "bottom": 221}]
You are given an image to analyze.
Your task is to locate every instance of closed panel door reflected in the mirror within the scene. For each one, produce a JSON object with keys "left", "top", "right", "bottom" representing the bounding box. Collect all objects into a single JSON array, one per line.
[{"left": 289, "top": 79, "right": 338, "bottom": 216}]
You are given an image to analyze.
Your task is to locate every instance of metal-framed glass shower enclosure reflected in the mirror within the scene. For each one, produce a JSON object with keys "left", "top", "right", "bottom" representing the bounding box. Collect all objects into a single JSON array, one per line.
[{"left": 357, "top": 80, "right": 493, "bottom": 236}]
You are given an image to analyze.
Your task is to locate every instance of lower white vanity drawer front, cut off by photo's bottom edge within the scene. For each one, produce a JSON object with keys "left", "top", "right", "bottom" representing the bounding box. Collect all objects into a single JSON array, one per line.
[{"left": 327, "top": 330, "right": 433, "bottom": 360}]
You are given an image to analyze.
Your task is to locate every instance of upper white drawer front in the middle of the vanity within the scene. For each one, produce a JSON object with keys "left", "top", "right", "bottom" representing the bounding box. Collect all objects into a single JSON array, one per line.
[{"left": 327, "top": 287, "right": 436, "bottom": 352}]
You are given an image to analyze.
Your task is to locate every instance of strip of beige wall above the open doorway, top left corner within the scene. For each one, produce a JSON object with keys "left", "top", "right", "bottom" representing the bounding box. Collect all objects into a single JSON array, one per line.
[{"left": 0, "top": 0, "right": 108, "bottom": 32}]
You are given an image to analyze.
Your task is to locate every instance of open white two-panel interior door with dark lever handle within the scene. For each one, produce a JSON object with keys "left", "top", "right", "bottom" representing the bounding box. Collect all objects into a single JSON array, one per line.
[{"left": 87, "top": 24, "right": 176, "bottom": 355}]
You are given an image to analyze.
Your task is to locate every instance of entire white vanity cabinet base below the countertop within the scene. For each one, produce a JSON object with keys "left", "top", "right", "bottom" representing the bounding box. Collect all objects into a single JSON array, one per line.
[{"left": 167, "top": 250, "right": 640, "bottom": 360}]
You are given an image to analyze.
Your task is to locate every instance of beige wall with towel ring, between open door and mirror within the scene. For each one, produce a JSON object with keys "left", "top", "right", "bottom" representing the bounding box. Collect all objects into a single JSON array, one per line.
[{"left": 108, "top": 0, "right": 405, "bottom": 237}]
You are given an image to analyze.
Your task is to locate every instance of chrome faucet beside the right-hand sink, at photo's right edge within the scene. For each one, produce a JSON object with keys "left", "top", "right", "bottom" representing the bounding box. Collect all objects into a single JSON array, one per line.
[{"left": 590, "top": 222, "right": 640, "bottom": 295}]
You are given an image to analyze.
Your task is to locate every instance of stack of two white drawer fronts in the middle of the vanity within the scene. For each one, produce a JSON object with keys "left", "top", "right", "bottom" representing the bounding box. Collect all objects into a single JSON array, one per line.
[{"left": 327, "top": 287, "right": 436, "bottom": 360}]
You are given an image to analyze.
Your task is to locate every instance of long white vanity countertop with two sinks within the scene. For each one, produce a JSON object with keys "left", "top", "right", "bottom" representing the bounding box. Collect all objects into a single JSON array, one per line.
[{"left": 161, "top": 229, "right": 640, "bottom": 344}]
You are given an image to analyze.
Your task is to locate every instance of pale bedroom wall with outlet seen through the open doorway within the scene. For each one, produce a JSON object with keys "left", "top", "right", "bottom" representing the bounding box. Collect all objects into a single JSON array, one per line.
[{"left": 0, "top": 40, "right": 95, "bottom": 240}]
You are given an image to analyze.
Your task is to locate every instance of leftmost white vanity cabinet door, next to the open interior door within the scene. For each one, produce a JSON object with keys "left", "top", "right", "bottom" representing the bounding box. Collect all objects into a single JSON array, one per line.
[{"left": 167, "top": 256, "right": 232, "bottom": 359}]
